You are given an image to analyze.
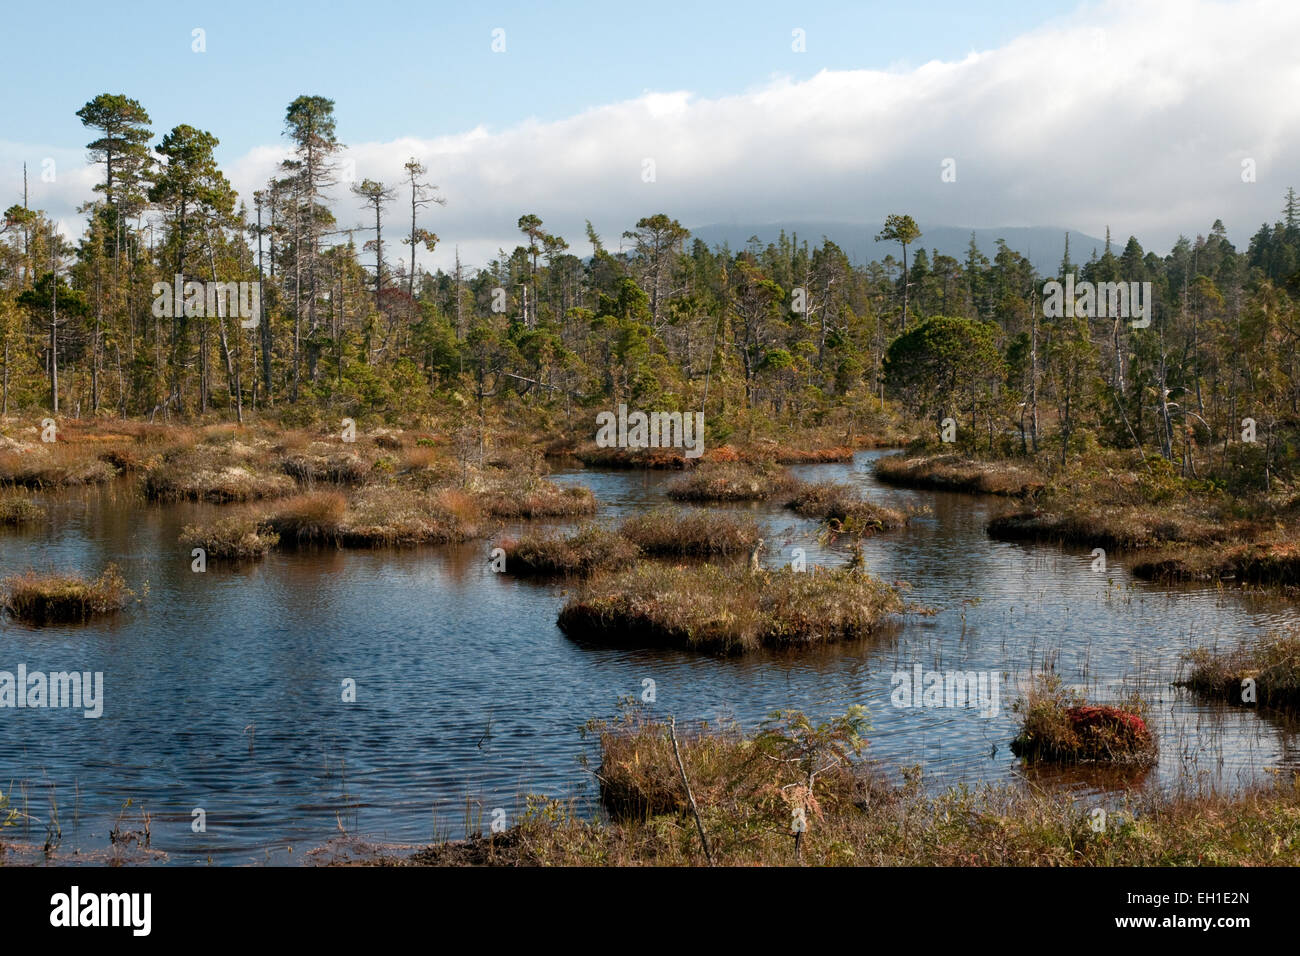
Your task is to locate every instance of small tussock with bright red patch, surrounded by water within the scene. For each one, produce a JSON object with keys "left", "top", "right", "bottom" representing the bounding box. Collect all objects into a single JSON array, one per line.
[{"left": 1011, "top": 675, "right": 1157, "bottom": 765}]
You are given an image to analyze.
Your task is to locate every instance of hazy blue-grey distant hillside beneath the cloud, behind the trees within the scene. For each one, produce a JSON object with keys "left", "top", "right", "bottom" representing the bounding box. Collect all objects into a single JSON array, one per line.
[{"left": 690, "top": 221, "right": 1107, "bottom": 273}]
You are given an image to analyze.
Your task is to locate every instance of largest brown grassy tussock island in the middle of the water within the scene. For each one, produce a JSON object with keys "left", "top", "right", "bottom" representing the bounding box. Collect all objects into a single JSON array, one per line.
[{"left": 559, "top": 562, "right": 902, "bottom": 654}]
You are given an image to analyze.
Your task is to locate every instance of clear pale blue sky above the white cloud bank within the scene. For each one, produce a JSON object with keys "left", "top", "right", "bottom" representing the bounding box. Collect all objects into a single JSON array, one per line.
[{"left": 0, "top": 0, "right": 1078, "bottom": 166}]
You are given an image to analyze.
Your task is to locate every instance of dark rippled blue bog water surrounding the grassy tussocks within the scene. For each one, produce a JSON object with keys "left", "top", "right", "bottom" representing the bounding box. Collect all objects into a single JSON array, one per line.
[{"left": 0, "top": 453, "right": 1300, "bottom": 862}]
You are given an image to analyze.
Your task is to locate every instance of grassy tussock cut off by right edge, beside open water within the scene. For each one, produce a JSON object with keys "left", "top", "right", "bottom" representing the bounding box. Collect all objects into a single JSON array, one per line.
[{"left": 1182, "top": 628, "right": 1300, "bottom": 711}]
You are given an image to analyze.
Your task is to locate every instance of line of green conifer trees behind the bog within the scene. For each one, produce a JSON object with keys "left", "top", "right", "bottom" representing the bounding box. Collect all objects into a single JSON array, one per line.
[{"left": 0, "top": 94, "right": 1300, "bottom": 481}]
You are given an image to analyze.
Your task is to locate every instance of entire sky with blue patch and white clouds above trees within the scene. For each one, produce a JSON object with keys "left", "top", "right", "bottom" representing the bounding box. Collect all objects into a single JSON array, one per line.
[{"left": 0, "top": 0, "right": 1300, "bottom": 274}]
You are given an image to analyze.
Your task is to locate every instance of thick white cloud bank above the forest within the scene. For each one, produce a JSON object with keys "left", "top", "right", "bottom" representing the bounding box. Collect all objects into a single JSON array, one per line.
[{"left": 0, "top": 0, "right": 1300, "bottom": 277}]
